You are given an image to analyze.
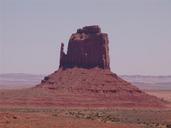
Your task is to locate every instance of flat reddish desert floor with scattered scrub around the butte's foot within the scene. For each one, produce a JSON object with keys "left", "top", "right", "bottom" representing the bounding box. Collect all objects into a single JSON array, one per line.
[{"left": 0, "top": 90, "right": 171, "bottom": 128}]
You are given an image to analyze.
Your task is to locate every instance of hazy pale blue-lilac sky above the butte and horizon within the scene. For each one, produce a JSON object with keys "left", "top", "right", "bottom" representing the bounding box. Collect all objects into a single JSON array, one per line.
[{"left": 0, "top": 0, "right": 171, "bottom": 75}]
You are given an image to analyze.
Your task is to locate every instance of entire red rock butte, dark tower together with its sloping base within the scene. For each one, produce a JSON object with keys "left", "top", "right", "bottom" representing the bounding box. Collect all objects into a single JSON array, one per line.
[{"left": 36, "top": 25, "right": 163, "bottom": 107}]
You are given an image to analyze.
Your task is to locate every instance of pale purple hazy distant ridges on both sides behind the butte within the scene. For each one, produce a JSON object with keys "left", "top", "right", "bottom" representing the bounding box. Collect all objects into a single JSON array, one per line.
[{"left": 0, "top": 73, "right": 171, "bottom": 90}]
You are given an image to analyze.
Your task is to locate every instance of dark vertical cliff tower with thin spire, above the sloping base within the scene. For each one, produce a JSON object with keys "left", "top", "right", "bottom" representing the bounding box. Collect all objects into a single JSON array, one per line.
[{"left": 59, "top": 26, "right": 110, "bottom": 69}]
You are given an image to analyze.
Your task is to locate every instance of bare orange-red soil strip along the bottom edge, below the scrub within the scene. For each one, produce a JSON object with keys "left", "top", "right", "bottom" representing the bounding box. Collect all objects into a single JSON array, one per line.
[{"left": 0, "top": 113, "right": 140, "bottom": 128}]
